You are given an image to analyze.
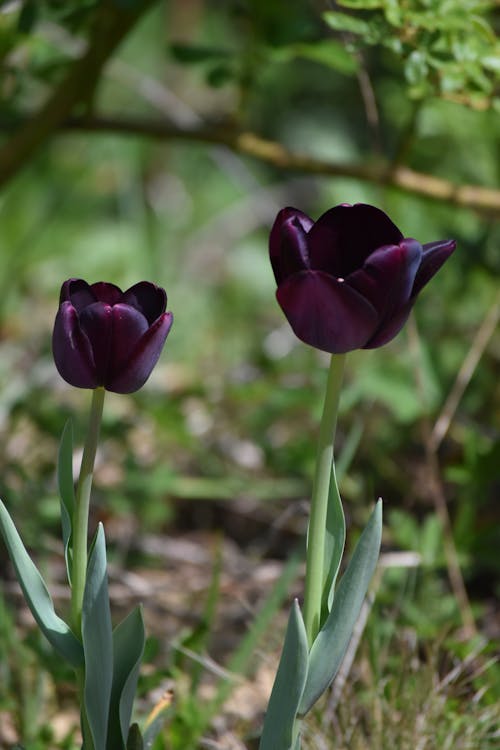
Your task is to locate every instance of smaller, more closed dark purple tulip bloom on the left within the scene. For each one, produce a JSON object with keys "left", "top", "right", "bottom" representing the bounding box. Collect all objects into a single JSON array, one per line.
[{"left": 52, "top": 279, "right": 173, "bottom": 393}]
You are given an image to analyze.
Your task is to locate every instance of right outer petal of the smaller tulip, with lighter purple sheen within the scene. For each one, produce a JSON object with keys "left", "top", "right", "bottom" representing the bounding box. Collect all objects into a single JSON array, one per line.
[{"left": 106, "top": 313, "right": 173, "bottom": 393}]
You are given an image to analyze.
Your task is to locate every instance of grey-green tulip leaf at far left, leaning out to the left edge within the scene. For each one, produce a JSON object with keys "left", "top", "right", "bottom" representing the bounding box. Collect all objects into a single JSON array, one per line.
[{"left": 0, "top": 500, "right": 83, "bottom": 667}]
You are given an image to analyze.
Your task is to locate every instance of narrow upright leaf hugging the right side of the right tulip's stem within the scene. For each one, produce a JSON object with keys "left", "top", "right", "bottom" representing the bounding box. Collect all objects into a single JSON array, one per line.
[{"left": 321, "top": 464, "right": 345, "bottom": 625}]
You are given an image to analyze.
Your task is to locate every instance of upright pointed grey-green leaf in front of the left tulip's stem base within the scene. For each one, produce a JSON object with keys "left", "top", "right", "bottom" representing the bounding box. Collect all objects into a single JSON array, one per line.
[{"left": 82, "top": 524, "right": 113, "bottom": 750}]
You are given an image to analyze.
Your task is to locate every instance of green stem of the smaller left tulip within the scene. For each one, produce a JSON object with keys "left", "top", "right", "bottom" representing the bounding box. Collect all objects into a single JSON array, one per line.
[{"left": 71, "top": 388, "right": 106, "bottom": 637}]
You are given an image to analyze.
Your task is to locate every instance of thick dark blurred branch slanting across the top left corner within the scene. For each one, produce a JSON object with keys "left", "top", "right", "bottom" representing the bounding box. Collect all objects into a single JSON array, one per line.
[{"left": 0, "top": 0, "right": 158, "bottom": 185}]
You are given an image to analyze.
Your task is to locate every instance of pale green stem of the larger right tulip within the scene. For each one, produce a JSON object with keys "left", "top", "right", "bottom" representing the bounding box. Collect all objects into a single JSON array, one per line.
[{"left": 304, "top": 354, "right": 346, "bottom": 646}]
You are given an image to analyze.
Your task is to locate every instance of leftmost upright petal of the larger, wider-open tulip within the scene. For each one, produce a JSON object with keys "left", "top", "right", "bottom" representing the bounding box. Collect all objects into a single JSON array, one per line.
[{"left": 269, "top": 208, "right": 314, "bottom": 285}]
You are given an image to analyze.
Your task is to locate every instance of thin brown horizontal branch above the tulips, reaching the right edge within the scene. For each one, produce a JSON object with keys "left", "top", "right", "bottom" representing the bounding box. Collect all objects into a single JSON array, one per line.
[{"left": 57, "top": 115, "right": 500, "bottom": 213}]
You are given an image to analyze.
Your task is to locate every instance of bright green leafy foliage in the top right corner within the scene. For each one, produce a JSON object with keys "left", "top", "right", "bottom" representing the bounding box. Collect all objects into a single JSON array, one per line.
[{"left": 323, "top": 0, "right": 500, "bottom": 107}]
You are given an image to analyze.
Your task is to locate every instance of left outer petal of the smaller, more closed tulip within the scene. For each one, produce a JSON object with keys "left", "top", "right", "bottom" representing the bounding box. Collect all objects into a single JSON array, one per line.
[{"left": 52, "top": 301, "right": 100, "bottom": 388}]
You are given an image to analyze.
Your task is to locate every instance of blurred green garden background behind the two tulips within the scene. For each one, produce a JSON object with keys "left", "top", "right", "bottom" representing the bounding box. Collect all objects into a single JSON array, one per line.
[{"left": 0, "top": 0, "right": 500, "bottom": 750}]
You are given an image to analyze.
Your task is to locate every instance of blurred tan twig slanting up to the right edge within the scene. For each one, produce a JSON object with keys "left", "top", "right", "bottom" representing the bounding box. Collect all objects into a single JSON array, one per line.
[{"left": 430, "top": 292, "right": 500, "bottom": 451}]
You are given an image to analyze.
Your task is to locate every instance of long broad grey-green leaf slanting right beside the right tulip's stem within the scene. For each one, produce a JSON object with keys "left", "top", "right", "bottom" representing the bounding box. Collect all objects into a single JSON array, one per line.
[{"left": 299, "top": 500, "right": 382, "bottom": 716}]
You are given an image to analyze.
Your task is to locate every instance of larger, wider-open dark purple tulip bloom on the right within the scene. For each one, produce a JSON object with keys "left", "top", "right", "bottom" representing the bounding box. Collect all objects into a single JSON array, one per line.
[{"left": 269, "top": 203, "right": 455, "bottom": 354}]
